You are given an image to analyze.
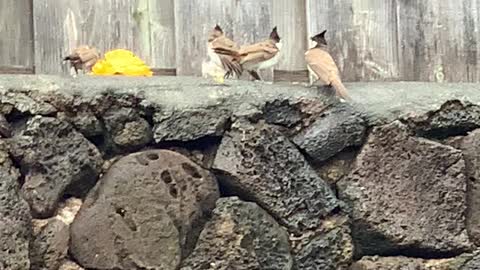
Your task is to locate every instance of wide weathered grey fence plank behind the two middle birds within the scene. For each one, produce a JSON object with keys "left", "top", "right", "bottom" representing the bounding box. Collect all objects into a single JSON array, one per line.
[{"left": 175, "top": 0, "right": 273, "bottom": 80}]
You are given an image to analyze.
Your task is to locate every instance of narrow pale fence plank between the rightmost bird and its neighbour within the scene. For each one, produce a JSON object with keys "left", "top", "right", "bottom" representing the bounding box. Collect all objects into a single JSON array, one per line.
[{"left": 273, "top": 0, "right": 308, "bottom": 71}]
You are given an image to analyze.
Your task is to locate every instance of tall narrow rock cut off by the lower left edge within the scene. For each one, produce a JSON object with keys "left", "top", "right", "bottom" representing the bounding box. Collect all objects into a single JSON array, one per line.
[{"left": 0, "top": 149, "right": 32, "bottom": 270}]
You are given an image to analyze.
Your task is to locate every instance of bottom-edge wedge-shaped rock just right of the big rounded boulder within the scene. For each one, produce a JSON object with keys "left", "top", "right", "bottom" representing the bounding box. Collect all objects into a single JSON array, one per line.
[{"left": 181, "top": 197, "right": 293, "bottom": 270}]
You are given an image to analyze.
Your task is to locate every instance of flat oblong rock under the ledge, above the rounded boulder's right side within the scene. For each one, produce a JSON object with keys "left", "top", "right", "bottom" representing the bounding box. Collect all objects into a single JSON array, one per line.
[{"left": 153, "top": 108, "right": 231, "bottom": 143}]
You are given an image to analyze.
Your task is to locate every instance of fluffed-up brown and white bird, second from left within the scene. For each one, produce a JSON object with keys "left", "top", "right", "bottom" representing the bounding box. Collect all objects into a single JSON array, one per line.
[{"left": 202, "top": 24, "right": 243, "bottom": 81}]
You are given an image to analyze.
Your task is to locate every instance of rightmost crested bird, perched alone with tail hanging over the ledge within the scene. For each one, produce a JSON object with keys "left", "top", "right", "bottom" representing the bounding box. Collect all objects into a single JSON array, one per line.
[{"left": 305, "top": 30, "right": 351, "bottom": 100}]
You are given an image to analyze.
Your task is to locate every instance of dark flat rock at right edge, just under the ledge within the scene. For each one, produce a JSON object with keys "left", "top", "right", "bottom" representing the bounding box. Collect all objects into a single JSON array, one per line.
[{"left": 405, "top": 100, "right": 480, "bottom": 138}]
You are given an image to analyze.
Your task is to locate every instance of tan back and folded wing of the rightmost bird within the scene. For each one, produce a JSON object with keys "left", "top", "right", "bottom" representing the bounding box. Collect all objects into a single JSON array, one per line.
[{"left": 305, "top": 48, "right": 340, "bottom": 85}]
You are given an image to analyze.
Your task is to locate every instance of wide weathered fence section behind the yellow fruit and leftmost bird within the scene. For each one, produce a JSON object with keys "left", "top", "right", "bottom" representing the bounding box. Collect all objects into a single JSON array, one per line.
[{"left": 34, "top": 0, "right": 175, "bottom": 74}]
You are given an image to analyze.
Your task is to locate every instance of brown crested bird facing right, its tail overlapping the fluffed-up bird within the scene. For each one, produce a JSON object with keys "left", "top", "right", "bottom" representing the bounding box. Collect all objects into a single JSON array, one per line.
[{"left": 214, "top": 26, "right": 282, "bottom": 81}]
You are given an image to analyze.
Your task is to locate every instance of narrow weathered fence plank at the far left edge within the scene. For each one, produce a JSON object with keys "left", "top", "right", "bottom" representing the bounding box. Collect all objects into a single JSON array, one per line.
[{"left": 0, "top": 0, "right": 33, "bottom": 70}]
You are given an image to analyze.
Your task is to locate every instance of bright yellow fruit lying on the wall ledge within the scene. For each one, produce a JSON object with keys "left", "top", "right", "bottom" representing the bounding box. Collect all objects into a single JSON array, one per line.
[{"left": 92, "top": 49, "right": 153, "bottom": 77}]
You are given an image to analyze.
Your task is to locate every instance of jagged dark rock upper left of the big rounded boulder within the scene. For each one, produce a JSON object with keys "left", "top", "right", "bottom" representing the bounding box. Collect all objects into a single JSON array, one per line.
[{"left": 10, "top": 116, "right": 103, "bottom": 217}]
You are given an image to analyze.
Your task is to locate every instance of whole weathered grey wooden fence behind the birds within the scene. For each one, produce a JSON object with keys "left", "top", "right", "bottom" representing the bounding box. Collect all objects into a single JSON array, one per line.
[{"left": 0, "top": 0, "right": 480, "bottom": 82}]
